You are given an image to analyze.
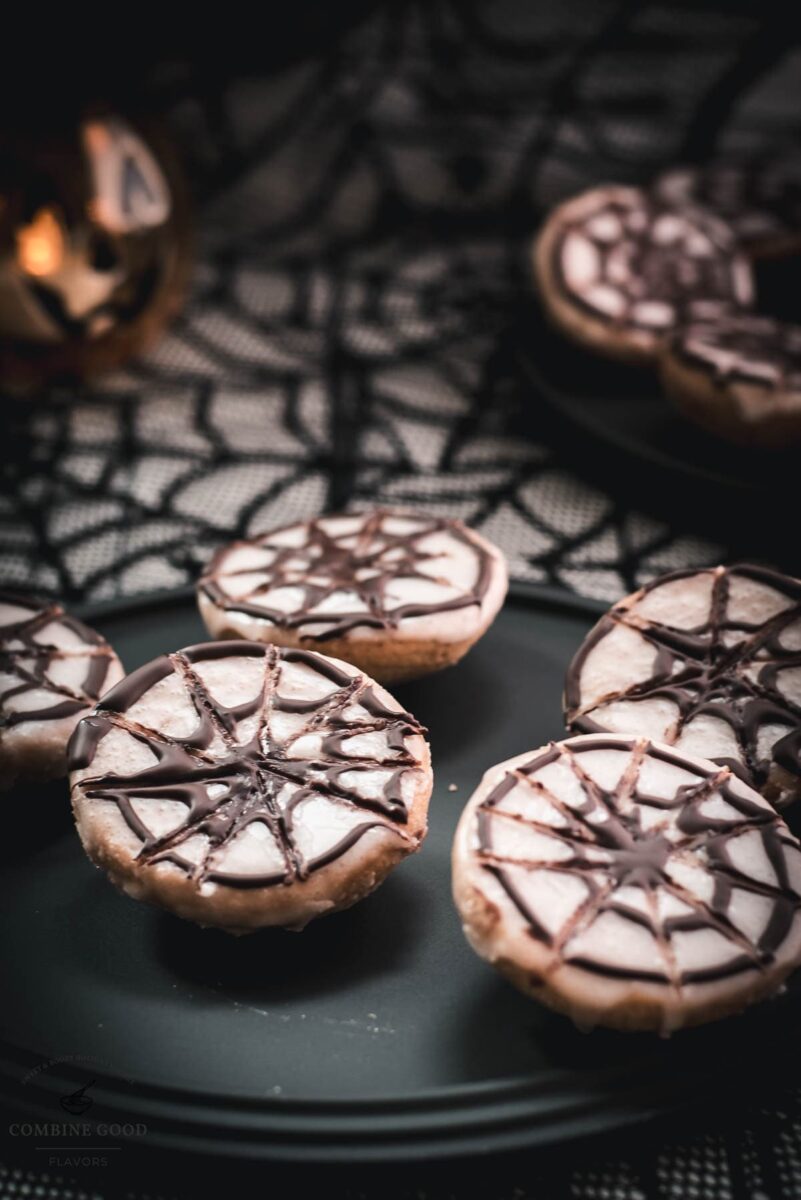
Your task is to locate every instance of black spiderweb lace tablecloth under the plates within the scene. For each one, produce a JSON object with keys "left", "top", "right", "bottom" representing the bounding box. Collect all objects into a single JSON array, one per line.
[{"left": 0, "top": 0, "right": 801, "bottom": 1200}]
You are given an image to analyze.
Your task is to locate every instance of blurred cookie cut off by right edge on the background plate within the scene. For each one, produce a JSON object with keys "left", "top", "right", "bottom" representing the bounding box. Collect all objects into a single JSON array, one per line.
[{"left": 660, "top": 313, "right": 801, "bottom": 449}]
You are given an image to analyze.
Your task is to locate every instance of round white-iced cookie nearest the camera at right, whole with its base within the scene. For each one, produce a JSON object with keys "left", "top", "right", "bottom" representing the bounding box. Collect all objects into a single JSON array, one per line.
[{"left": 453, "top": 734, "right": 801, "bottom": 1033}]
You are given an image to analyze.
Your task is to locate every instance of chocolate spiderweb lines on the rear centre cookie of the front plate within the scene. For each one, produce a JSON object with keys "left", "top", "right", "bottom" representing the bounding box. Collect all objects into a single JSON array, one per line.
[{"left": 200, "top": 509, "right": 490, "bottom": 641}]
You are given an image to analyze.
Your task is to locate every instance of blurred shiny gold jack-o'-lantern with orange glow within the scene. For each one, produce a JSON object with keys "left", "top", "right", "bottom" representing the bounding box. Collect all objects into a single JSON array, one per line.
[{"left": 0, "top": 112, "right": 189, "bottom": 388}]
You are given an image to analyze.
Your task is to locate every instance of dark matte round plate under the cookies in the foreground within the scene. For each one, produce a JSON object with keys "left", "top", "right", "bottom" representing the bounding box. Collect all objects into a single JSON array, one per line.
[{"left": 0, "top": 585, "right": 799, "bottom": 1162}]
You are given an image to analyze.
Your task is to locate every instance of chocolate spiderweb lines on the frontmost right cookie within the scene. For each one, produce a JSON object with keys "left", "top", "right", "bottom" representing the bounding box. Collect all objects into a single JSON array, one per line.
[{"left": 477, "top": 738, "right": 801, "bottom": 989}]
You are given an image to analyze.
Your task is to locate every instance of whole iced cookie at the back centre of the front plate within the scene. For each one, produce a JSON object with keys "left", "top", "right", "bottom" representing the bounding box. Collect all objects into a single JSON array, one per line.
[{"left": 198, "top": 509, "right": 508, "bottom": 683}]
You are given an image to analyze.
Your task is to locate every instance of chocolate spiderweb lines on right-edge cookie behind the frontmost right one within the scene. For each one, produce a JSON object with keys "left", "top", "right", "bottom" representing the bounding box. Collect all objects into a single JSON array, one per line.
[{"left": 565, "top": 565, "right": 801, "bottom": 798}]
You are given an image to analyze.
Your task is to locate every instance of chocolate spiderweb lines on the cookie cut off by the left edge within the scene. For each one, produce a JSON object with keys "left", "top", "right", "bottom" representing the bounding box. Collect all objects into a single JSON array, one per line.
[{"left": 0, "top": 592, "right": 113, "bottom": 731}]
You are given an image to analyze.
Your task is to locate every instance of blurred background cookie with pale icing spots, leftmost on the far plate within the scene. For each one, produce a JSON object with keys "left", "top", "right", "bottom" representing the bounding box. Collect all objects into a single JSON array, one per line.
[{"left": 534, "top": 187, "right": 754, "bottom": 362}]
